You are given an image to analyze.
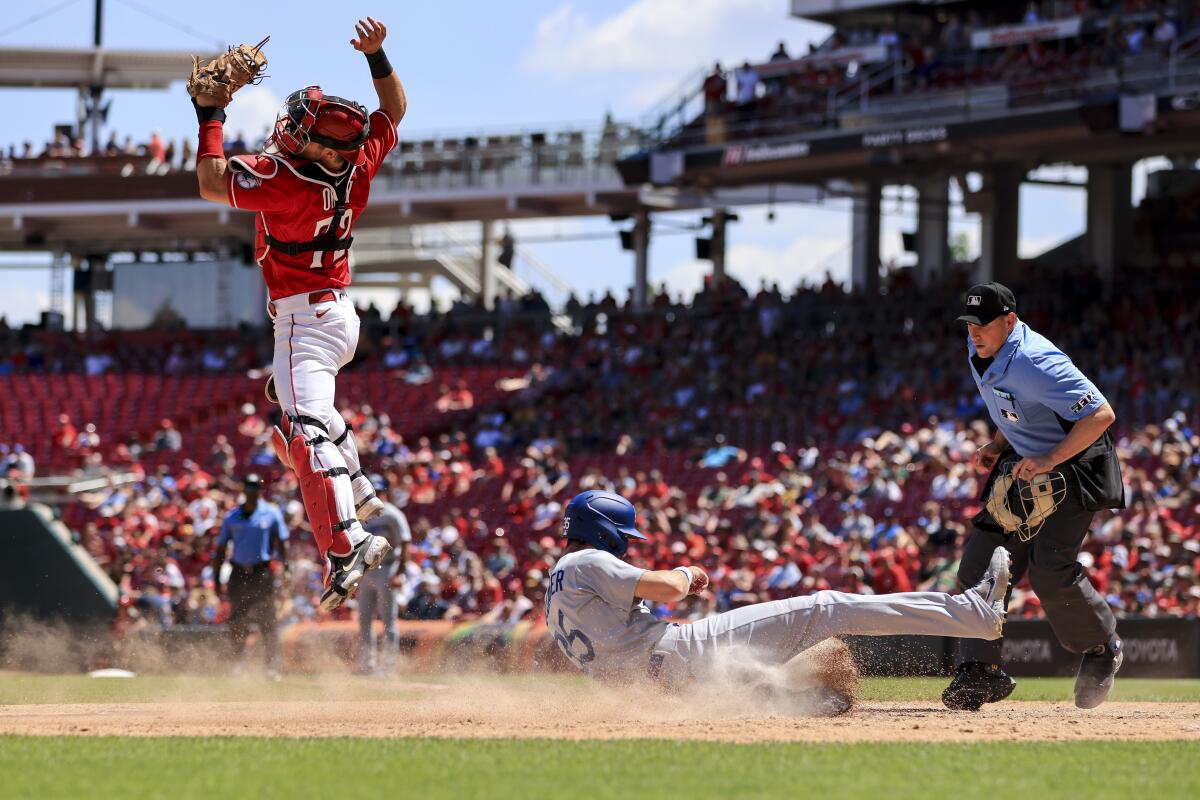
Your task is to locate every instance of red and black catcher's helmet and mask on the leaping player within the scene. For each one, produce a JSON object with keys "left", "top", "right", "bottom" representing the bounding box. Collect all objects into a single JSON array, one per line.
[{"left": 270, "top": 86, "right": 371, "bottom": 163}]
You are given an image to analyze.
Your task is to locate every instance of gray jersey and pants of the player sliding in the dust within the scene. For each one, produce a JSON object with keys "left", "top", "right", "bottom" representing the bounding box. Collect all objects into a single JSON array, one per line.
[{"left": 546, "top": 549, "right": 998, "bottom": 685}]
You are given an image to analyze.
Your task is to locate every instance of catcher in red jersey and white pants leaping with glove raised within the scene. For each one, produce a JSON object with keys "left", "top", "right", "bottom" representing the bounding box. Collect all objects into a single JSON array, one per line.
[{"left": 188, "top": 17, "right": 407, "bottom": 610}]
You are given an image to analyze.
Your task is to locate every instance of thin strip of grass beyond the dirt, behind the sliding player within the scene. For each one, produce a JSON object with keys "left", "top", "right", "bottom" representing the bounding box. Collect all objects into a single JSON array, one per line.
[{"left": 0, "top": 674, "right": 1200, "bottom": 705}]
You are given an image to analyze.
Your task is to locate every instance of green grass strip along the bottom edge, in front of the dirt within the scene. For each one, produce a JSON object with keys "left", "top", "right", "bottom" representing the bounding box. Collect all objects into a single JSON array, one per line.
[{"left": 0, "top": 736, "right": 1200, "bottom": 800}]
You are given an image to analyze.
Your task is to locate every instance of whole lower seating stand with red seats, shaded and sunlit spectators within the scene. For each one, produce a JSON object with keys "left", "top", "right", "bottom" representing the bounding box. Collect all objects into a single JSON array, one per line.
[{"left": 0, "top": 267, "right": 1200, "bottom": 642}]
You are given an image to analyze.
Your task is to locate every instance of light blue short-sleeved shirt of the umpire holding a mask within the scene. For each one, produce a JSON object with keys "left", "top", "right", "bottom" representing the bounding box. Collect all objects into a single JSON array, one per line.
[{"left": 967, "top": 321, "right": 1108, "bottom": 458}]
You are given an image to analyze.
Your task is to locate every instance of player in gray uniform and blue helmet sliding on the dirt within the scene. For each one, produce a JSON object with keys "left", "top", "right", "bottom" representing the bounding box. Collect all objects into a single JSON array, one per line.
[{"left": 545, "top": 489, "right": 1009, "bottom": 711}]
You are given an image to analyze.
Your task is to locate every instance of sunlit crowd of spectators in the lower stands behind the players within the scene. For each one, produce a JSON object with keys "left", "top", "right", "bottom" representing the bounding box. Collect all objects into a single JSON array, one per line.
[{"left": 51, "top": 409, "right": 1200, "bottom": 638}]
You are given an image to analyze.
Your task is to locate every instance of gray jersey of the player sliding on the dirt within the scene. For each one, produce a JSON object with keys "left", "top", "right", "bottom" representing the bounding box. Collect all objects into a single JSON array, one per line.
[{"left": 546, "top": 549, "right": 668, "bottom": 678}]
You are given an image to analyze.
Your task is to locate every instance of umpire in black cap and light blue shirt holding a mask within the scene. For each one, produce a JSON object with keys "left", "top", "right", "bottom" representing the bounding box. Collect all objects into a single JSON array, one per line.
[{"left": 942, "top": 283, "right": 1124, "bottom": 711}]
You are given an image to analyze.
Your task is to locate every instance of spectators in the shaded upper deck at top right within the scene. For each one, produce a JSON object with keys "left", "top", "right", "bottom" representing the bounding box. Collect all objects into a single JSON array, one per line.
[{"left": 683, "top": 0, "right": 1200, "bottom": 139}]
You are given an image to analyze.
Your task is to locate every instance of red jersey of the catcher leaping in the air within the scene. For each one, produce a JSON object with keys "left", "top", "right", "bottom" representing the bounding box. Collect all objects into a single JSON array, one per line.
[{"left": 227, "top": 108, "right": 400, "bottom": 300}]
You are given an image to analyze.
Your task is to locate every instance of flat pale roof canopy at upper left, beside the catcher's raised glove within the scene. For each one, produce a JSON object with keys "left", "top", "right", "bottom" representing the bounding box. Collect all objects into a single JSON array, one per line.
[{"left": 0, "top": 47, "right": 192, "bottom": 89}]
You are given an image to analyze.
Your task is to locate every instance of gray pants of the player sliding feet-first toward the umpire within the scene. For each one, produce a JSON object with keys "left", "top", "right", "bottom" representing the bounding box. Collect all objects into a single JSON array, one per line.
[{"left": 654, "top": 591, "right": 1000, "bottom": 684}]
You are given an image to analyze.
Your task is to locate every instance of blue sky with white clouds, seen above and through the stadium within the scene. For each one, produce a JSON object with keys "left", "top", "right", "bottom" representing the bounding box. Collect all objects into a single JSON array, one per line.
[{"left": 0, "top": 0, "right": 1104, "bottom": 321}]
